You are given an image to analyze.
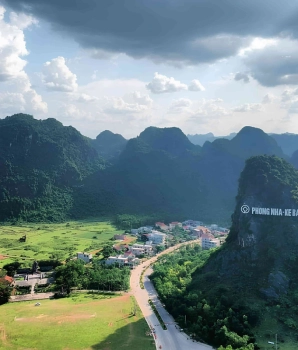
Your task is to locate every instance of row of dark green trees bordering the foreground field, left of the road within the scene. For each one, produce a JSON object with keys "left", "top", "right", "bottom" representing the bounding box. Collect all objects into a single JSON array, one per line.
[{"left": 56, "top": 260, "right": 130, "bottom": 294}]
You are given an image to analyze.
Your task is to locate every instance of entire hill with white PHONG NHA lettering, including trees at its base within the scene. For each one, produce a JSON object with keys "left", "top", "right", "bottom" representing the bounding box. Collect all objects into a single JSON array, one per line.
[{"left": 171, "top": 156, "right": 298, "bottom": 349}]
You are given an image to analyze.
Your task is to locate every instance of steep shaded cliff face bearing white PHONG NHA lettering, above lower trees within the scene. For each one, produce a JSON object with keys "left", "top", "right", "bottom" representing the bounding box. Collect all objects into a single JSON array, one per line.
[{"left": 200, "top": 156, "right": 298, "bottom": 299}]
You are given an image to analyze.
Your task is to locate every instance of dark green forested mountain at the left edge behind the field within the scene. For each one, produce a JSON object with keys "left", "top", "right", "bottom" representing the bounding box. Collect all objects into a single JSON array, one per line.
[{"left": 0, "top": 114, "right": 105, "bottom": 220}]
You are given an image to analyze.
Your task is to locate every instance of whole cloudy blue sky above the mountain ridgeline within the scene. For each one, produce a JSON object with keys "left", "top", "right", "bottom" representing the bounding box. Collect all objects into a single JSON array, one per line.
[{"left": 0, "top": 0, "right": 298, "bottom": 138}]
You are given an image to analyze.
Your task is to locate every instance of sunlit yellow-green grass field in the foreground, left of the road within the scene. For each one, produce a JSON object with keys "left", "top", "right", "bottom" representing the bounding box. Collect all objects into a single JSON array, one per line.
[{"left": 0, "top": 294, "right": 155, "bottom": 350}]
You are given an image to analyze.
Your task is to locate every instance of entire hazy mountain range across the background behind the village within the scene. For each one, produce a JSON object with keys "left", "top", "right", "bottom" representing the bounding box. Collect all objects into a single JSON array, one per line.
[{"left": 0, "top": 114, "right": 298, "bottom": 225}]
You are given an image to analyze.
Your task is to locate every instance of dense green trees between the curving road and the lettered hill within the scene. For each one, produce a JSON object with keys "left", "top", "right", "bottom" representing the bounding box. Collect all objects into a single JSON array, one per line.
[{"left": 151, "top": 245, "right": 258, "bottom": 350}]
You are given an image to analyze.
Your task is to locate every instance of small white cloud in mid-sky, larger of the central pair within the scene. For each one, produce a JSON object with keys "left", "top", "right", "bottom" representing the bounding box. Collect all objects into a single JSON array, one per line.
[{"left": 146, "top": 72, "right": 187, "bottom": 94}]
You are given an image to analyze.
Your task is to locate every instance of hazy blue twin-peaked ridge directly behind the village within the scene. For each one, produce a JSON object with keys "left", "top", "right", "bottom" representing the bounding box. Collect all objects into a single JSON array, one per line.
[{"left": 76, "top": 127, "right": 284, "bottom": 225}]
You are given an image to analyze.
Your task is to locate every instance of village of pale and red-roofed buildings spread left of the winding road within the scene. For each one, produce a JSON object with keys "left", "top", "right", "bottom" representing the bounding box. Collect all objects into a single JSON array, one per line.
[{"left": 2, "top": 220, "right": 229, "bottom": 301}]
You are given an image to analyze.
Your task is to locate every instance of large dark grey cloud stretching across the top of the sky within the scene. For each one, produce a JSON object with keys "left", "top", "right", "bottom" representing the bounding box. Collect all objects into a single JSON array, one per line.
[{"left": 2, "top": 0, "right": 298, "bottom": 64}]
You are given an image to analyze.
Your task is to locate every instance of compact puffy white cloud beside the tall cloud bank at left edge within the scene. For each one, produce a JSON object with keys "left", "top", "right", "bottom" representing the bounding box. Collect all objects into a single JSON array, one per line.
[{"left": 42, "top": 56, "right": 78, "bottom": 92}]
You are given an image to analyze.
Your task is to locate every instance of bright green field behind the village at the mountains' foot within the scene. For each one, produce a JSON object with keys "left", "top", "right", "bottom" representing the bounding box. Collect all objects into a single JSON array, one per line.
[{"left": 0, "top": 221, "right": 133, "bottom": 267}]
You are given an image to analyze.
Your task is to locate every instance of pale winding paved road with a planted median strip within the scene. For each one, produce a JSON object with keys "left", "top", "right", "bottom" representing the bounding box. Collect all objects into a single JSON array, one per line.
[{"left": 130, "top": 241, "right": 213, "bottom": 350}]
